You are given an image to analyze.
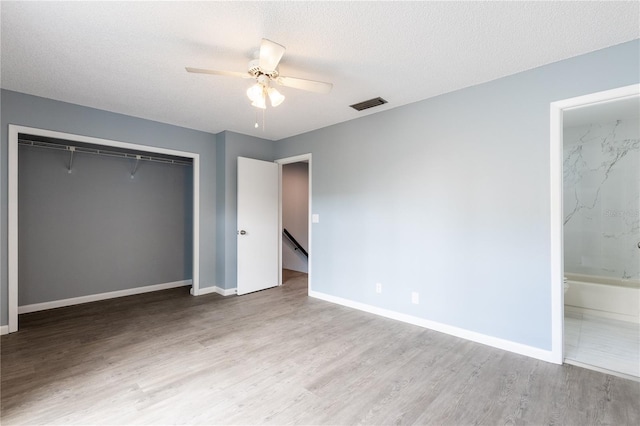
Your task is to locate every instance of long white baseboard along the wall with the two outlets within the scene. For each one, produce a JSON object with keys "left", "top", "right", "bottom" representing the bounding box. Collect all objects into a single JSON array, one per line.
[{"left": 309, "top": 290, "right": 556, "bottom": 364}]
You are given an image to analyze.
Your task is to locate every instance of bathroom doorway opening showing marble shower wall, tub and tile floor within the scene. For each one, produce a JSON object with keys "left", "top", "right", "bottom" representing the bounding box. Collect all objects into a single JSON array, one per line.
[{"left": 557, "top": 86, "right": 640, "bottom": 380}]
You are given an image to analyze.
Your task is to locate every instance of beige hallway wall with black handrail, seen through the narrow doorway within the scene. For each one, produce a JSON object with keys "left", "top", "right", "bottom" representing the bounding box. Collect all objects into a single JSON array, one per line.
[{"left": 282, "top": 163, "right": 309, "bottom": 272}]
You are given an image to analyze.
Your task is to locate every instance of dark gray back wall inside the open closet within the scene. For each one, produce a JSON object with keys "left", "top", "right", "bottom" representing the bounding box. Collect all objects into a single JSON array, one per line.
[{"left": 18, "top": 146, "right": 193, "bottom": 306}]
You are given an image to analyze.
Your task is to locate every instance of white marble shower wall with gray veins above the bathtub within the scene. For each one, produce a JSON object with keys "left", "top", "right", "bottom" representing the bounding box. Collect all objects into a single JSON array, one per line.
[{"left": 563, "top": 120, "right": 640, "bottom": 280}]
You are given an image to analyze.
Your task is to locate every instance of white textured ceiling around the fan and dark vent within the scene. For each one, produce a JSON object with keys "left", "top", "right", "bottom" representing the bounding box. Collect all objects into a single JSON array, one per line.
[{"left": 0, "top": 1, "right": 640, "bottom": 140}]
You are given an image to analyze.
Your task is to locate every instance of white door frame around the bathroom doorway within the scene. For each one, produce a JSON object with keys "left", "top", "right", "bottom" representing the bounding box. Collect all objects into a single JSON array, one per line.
[{"left": 550, "top": 84, "right": 640, "bottom": 364}]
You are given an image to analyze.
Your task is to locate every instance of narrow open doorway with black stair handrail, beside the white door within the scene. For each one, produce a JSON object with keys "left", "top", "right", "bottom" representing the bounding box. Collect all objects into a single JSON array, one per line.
[{"left": 276, "top": 154, "right": 312, "bottom": 293}]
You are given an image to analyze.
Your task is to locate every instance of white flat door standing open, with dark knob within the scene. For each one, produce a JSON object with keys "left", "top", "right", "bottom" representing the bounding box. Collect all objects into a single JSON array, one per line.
[{"left": 237, "top": 157, "right": 279, "bottom": 294}]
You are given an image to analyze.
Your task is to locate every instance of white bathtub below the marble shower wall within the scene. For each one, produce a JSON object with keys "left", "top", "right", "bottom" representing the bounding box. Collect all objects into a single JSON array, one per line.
[{"left": 564, "top": 273, "right": 640, "bottom": 323}]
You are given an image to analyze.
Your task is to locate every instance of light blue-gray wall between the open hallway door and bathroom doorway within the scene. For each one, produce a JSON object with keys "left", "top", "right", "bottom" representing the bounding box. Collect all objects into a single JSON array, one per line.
[{"left": 276, "top": 40, "right": 640, "bottom": 350}]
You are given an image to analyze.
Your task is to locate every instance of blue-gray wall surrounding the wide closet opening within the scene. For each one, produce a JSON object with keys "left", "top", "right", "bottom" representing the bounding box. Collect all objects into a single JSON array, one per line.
[{"left": 0, "top": 90, "right": 216, "bottom": 325}]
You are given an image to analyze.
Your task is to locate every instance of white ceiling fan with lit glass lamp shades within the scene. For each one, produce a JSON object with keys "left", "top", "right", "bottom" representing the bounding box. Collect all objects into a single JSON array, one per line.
[{"left": 185, "top": 38, "right": 333, "bottom": 109}]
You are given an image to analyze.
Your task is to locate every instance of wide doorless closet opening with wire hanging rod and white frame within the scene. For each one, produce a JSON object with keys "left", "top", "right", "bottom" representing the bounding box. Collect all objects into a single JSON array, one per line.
[{"left": 8, "top": 125, "right": 199, "bottom": 332}]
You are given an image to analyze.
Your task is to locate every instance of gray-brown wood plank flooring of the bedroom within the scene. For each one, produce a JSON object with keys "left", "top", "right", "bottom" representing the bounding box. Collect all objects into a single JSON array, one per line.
[{"left": 0, "top": 273, "right": 640, "bottom": 425}]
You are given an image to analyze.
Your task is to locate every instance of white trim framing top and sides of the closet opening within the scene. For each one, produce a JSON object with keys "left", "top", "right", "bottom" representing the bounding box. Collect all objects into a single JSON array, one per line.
[{"left": 7, "top": 124, "right": 200, "bottom": 333}]
